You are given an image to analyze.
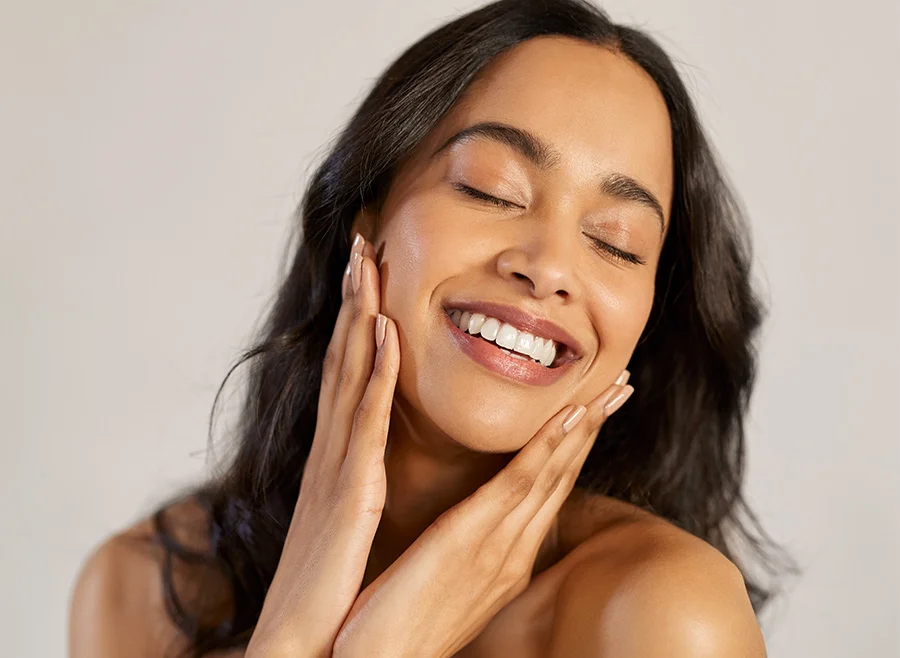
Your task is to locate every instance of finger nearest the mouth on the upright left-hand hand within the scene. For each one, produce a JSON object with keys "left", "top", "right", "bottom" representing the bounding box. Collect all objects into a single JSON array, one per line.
[{"left": 344, "top": 315, "right": 400, "bottom": 486}]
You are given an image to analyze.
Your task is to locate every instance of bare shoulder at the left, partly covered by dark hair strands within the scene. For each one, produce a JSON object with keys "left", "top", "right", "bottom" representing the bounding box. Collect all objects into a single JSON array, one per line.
[{"left": 69, "top": 494, "right": 225, "bottom": 658}]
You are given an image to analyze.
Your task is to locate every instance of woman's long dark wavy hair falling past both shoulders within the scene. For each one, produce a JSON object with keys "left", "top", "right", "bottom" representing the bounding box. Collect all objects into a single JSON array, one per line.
[{"left": 153, "top": 0, "right": 796, "bottom": 656}]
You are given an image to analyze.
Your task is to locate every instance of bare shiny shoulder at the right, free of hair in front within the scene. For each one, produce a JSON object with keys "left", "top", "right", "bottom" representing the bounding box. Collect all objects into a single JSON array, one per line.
[{"left": 550, "top": 502, "right": 766, "bottom": 658}]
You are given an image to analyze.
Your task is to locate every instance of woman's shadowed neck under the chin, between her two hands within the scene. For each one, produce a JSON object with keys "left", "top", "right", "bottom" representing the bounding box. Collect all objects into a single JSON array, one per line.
[{"left": 363, "top": 398, "right": 513, "bottom": 587}]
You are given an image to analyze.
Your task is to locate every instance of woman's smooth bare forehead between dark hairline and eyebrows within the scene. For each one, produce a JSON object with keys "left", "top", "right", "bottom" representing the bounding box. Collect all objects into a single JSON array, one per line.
[{"left": 414, "top": 37, "right": 672, "bottom": 217}]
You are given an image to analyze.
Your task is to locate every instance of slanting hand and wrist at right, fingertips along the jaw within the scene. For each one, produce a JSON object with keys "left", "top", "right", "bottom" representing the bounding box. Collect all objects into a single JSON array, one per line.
[{"left": 334, "top": 370, "right": 633, "bottom": 658}]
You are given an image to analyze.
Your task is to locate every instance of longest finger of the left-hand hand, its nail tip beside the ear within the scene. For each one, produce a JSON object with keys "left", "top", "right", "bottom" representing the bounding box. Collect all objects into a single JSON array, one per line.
[{"left": 326, "top": 249, "right": 381, "bottom": 463}]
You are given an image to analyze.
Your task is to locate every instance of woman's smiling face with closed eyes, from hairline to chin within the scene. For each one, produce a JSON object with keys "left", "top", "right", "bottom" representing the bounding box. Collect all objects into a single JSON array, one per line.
[{"left": 356, "top": 37, "right": 672, "bottom": 452}]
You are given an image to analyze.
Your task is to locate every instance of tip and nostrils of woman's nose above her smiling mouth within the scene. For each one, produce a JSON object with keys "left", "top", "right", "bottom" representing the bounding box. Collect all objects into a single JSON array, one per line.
[{"left": 497, "top": 222, "right": 577, "bottom": 301}]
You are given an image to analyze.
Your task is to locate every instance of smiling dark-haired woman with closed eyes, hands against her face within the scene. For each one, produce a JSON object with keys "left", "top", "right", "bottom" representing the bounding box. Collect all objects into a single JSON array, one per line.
[{"left": 71, "top": 0, "right": 788, "bottom": 658}]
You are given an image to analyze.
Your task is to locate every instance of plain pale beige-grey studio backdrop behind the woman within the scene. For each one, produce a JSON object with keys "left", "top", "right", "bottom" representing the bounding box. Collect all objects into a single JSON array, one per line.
[{"left": 0, "top": 0, "right": 900, "bottom": 658}]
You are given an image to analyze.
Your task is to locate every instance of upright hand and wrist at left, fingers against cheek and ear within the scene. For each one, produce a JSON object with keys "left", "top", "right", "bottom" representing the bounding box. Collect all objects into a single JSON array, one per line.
[{"left": 246, "top": 236, "right": 400, "bottom": 658}]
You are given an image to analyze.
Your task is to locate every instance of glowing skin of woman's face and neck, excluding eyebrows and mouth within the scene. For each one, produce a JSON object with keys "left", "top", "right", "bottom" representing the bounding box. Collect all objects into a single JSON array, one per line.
[{"left": 353, "top": 37, "right": 673, "bottom": 581}]
